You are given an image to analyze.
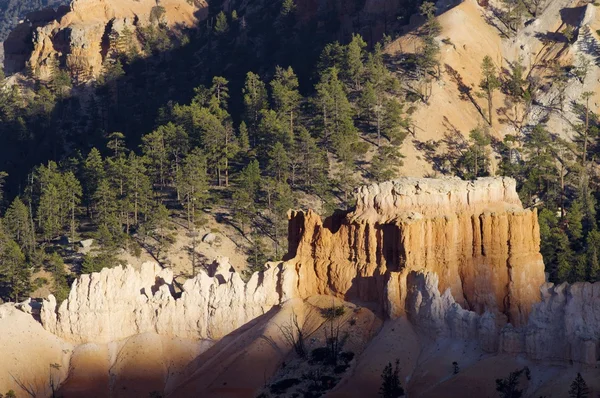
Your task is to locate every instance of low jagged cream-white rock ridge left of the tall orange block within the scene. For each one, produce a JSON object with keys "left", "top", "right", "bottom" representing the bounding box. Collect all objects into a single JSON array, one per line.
[{"left": 40, "top": 259, "right": 295, "bottom": 343}]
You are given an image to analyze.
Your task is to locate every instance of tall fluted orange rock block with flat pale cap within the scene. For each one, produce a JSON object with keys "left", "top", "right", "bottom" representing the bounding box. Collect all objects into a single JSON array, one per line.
[{"left": 290, "top": 178, "right": 544, "bottom": 325}]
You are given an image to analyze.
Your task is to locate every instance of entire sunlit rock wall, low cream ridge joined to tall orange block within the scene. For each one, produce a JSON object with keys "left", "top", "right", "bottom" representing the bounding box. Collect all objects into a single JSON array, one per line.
[{"left": 41, "top": 178, "right": 544, "bottom": 343}]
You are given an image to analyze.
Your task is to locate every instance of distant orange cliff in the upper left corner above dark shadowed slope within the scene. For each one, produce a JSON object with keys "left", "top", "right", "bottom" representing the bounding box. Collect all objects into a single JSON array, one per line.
[{"left": 4, "top": 0, "right": 206, "bottom": 80}]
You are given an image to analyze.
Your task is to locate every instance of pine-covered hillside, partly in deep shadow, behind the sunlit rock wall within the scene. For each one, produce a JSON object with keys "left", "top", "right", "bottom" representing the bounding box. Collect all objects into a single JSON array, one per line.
[{"left": 0, "top": 0, "right": 600, "bottom": 300}]
